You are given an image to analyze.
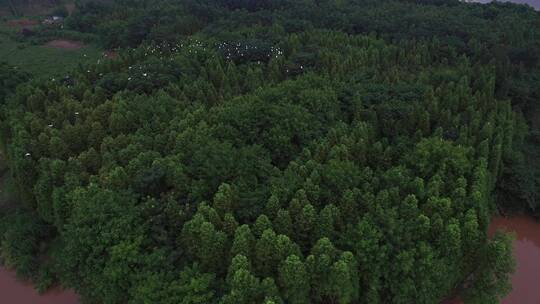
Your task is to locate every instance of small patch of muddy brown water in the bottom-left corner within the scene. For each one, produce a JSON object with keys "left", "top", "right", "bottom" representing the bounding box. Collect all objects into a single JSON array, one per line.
[{"left": 0, "top": 267, "right": 79, "bottom": 304}]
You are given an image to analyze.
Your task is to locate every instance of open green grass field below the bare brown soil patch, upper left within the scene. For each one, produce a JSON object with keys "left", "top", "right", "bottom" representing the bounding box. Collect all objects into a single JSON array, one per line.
[{"left": 0, "top": 23, "right": 102, "bottom": 77}]
